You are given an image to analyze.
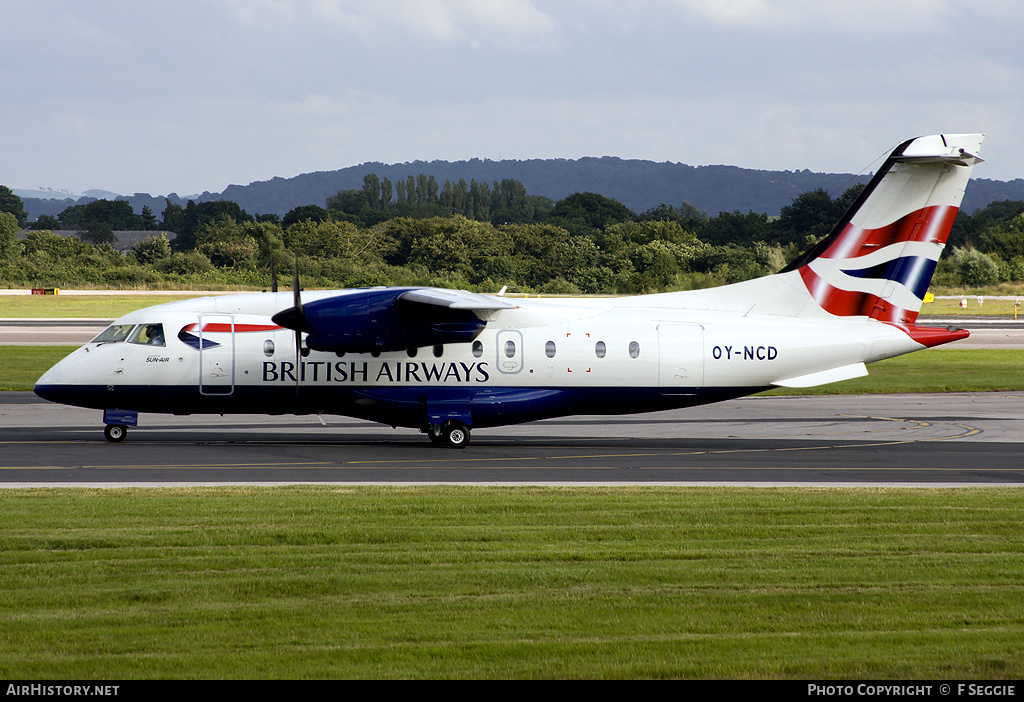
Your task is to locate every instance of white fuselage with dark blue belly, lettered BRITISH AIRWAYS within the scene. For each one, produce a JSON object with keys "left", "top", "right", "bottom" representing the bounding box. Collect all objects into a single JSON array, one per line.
[{"left": 37, "top": 283, "right": 923, "bottom": 426}]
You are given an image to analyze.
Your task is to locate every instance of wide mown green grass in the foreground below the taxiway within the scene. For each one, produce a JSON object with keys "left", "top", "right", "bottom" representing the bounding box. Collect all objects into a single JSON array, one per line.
[{"left": 0, "top": 486, "right": 1024, "bottom": 679}]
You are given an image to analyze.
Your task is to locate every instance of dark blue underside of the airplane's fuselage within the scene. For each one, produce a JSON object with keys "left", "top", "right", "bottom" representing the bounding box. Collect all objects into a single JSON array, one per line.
[{"left": 35, "top": 385, "right": 768, "bottom": 429}]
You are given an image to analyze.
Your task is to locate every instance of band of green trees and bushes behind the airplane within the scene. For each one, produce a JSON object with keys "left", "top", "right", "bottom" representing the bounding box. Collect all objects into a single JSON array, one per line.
[{"left": 0, "top": 184, "right": 1024, "bottom": 294}]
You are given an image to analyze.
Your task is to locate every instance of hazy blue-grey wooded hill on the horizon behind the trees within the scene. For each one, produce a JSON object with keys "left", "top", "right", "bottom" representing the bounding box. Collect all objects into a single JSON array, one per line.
[{"left": 23, "top": 157, "right": 1024, "bottom": 220}]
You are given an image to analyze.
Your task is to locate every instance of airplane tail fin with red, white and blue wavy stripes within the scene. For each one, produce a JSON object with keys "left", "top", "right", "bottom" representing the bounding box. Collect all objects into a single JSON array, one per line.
[{"left": 780, "top": 134, "right": 984, "bottom": 324}]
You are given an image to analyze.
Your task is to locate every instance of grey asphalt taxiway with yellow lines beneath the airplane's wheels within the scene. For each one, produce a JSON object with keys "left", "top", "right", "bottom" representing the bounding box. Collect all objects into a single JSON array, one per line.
[{"left": 0, "top": 393, "right": 1024, "bottom": 487}]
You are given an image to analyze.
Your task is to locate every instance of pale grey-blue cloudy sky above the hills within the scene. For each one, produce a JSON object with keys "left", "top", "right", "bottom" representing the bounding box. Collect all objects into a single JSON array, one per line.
[{"left": 0, "top": 0, "right": 1024, "bottom": 195}]
